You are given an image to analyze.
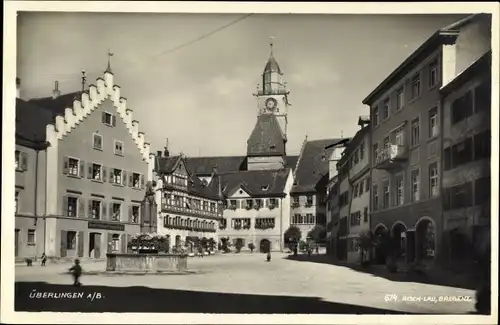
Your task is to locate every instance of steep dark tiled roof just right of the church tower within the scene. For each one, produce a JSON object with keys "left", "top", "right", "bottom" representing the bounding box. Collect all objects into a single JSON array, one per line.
[{"left": 291, "top": 139, "right": 342, "bottom": 193}]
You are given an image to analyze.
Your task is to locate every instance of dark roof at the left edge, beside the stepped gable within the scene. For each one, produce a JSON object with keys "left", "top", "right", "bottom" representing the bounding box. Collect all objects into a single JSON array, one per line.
[{"left": 16, "top": 98, "right": 53, "bottom": 149}]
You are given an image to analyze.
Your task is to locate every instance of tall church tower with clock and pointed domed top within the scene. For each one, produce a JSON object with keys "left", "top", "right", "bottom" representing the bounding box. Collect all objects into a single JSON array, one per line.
[{"left": 247, "top": 37, "right": 290, "bottom": 170}]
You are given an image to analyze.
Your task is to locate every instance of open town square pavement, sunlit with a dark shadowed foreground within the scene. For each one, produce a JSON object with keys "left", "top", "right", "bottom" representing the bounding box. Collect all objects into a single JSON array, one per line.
[{"left": 15, "top": 253, "right": 474, "bottom": 314}]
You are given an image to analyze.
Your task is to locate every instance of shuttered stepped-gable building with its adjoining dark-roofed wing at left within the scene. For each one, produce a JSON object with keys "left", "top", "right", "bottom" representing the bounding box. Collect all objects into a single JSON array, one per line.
[{"left": 16, "top": 63, "right": 152, "bottom": 258}]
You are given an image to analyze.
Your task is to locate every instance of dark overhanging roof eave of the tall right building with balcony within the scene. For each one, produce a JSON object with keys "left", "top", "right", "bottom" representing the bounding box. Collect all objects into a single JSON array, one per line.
[{"left": 363, "top": 14, "right": 484, "bottom": 105}]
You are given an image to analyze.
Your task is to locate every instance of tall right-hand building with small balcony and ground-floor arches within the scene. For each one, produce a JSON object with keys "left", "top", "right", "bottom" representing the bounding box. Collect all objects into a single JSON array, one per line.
[{"left": 363, "top": 14, "right": 491, "bottom": 264}]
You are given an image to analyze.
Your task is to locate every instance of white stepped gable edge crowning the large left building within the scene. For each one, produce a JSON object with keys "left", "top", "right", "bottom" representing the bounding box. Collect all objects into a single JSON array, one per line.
[{"left": 29, "top": 70, "right": 150, "bottom": 161}]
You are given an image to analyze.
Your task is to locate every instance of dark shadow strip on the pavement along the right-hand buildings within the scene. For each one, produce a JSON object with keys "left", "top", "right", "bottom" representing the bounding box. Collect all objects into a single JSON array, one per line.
[{"left": 285, "top": 254, "right": 476, "bottom": 290}]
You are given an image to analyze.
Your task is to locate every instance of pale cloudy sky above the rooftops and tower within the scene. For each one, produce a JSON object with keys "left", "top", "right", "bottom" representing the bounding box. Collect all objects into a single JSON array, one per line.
[{"left": 17, "top": 12, "right": 464, "bottom": 157}]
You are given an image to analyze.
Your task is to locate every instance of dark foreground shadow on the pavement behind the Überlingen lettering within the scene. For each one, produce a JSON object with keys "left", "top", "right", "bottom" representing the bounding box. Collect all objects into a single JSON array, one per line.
[{"left": 14, "top": 280, "right": 414, "bottom": 314}]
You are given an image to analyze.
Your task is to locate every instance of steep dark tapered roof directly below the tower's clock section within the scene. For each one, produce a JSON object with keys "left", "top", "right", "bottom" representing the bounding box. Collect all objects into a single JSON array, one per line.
[{"left": 247, "top": 114, "right": 286, "bottom": 156}]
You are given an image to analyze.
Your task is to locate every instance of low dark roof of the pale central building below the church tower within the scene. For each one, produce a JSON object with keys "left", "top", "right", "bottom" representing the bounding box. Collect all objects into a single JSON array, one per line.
[{"left": 217, "top": 168, "right": 291, "bottom": 197}]
